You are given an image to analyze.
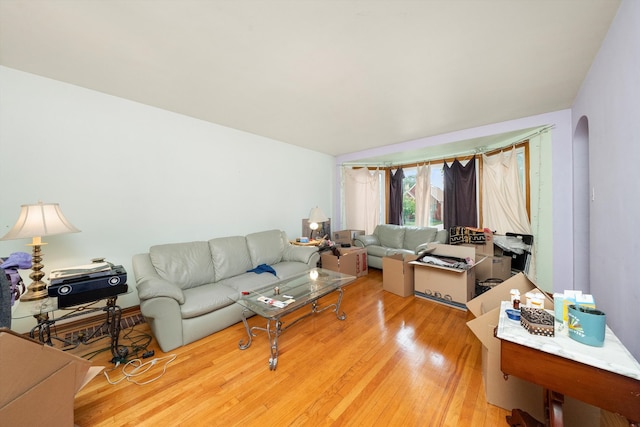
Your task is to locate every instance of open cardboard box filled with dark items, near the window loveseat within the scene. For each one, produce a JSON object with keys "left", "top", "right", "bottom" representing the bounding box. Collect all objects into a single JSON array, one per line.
[{"left": 411, "top": 244, "right": 484, "bottom": 310}]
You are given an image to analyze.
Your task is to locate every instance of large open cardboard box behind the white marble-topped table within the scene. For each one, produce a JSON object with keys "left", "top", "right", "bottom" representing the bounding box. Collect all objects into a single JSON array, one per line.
[{"left": 467, "top": 273, "right": 600, "bottom": 427}]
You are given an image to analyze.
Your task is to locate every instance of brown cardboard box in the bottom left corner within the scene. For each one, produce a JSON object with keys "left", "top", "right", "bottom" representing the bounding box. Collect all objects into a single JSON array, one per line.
[{"left": 0, "top": 329, "right": 102, "bottom": 426}]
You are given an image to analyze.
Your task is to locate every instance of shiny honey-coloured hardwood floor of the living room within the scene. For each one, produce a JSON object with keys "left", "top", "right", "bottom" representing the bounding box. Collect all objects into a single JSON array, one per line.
[{"left": 75, "top": 269, "right": 508, "bottom": 427}]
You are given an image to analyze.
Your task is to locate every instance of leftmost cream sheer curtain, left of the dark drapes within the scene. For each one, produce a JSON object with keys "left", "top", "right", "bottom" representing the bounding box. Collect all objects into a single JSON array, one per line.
[{"left": 343, "top": 167, "right": 380, "bottom": 234}]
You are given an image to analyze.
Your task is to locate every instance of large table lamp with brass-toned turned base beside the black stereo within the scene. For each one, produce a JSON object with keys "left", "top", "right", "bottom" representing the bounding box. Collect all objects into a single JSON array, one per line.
[{"left": 0, "top": 202, "right": 80, "bottom": 301}]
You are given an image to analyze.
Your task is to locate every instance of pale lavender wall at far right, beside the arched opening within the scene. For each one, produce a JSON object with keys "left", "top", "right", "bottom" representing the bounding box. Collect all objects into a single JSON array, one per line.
[{"left": 572, "top": 0, "right": 640, "bottom": 359}]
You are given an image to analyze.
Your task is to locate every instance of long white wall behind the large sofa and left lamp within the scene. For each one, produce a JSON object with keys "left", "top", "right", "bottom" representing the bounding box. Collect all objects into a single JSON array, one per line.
[{"left": 0, "top": 67, "right": 335, "bottom": 334}]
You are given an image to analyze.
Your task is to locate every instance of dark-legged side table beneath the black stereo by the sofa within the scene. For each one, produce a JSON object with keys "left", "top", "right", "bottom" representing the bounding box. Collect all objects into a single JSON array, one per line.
[{"left": 11, "top": 291, "right": 126, "bottom": 358}]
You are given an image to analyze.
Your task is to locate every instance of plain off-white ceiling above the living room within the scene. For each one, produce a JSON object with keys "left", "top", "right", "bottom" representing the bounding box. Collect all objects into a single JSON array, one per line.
[{"left": 0, "top": 0, "right": 620, "bottom": 161}]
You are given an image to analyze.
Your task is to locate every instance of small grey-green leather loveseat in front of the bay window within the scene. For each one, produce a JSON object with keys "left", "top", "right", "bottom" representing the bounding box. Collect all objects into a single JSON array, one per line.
[{"left": 354, "top": 224, "right": 448, "bottom": 269}]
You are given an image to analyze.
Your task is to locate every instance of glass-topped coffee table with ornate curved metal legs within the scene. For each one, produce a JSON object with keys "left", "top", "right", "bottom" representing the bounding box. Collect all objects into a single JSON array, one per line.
[{"left": 235, "top": 268, "right": 356, "bottom": 371}]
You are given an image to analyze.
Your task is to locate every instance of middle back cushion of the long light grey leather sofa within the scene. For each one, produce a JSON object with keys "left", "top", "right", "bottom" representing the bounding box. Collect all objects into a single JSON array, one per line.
[{"left": 209, "top": 236, "right": 253, "bottom": 282}]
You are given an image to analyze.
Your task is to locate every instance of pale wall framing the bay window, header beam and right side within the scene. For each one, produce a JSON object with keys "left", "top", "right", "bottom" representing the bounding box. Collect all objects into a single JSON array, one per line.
[{"left": 334, "top": 110, "right": 573, "bottom": 292}]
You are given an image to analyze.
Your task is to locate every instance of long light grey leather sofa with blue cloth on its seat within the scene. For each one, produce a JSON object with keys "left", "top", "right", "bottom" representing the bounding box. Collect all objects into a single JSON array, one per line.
[{"left": 133, "top": 230, "right": 320, "bottom": 352}]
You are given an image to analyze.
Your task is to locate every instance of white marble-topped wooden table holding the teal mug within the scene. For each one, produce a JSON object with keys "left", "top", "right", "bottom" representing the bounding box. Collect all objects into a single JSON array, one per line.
[{"left": 496, "top": 301, "right": 640, "bottom": 427}]
